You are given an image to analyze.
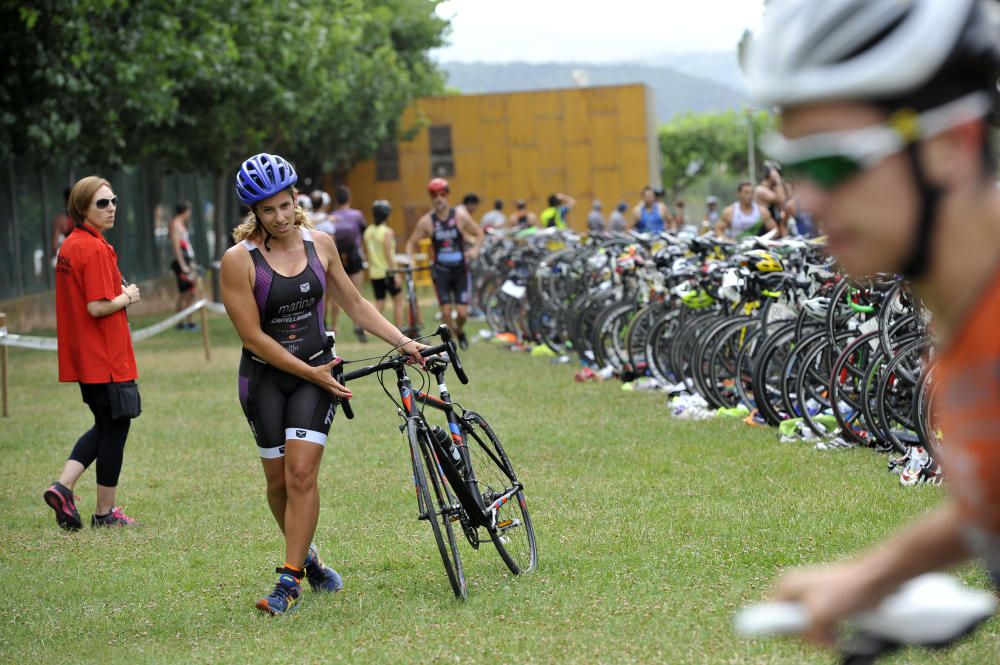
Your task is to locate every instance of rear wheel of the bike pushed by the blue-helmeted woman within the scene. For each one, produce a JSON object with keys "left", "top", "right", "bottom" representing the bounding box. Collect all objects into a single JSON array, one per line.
[{"left": 461, "top": 411, "right": 538, "bottom": 575}]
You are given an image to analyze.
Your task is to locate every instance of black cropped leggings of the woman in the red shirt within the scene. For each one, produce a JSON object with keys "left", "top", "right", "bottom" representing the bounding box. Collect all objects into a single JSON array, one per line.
[{"left": 69, "top": 383, "right": 132, "bottom": 487}]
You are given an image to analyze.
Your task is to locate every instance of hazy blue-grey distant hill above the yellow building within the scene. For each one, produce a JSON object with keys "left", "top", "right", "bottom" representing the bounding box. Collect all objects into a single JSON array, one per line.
[{"left": 441, "top": 62, "right": 746, "bottom": 122}]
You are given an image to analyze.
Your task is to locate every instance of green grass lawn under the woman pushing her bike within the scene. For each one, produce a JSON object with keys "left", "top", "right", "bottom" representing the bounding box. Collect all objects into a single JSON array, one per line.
[{"left": 0, "top": 308, "right": 1000, "bottom": 665}]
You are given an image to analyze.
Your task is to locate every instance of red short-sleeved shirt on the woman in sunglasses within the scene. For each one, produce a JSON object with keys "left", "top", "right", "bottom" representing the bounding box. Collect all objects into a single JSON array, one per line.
[{"left": 56, "top": 225, "right": 139, "bottom": 383}]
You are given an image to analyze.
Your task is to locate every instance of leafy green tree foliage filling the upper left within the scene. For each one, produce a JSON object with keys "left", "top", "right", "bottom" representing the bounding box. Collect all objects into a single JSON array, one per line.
[{"left": 0, "top": 0, "right": 447, "bottom": 172}]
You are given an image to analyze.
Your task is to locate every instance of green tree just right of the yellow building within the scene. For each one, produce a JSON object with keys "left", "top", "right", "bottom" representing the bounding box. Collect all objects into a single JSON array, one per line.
[{"left": 659, "top": 111, "right": 773, "bottom": 197}]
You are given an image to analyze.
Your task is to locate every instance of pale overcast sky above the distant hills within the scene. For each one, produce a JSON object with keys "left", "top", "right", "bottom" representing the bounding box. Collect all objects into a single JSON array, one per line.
[{"left": 434, "top": 0, "right": 764, "bottom": 62}]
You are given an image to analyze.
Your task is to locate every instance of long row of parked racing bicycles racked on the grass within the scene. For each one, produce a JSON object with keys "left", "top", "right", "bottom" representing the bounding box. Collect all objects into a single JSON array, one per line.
[{"left": 474, "top": 230, "right": 940, "bottom": 480}]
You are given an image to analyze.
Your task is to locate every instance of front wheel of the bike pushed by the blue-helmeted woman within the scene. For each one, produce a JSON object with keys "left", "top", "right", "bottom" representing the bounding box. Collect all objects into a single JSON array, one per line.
[{"left": 407, "top": 422, "right": 468, "bottom": 598}]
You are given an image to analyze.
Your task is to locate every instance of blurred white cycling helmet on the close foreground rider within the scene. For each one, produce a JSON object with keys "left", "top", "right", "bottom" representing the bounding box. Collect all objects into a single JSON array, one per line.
[{"left": 747, "top": 0, "right": 1000, "bottom": 108}]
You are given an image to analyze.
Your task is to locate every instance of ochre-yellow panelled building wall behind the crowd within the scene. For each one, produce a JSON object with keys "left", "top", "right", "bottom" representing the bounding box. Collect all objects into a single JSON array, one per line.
[{"left": 347, "top": 84, "right": 660, "bottom": 239}]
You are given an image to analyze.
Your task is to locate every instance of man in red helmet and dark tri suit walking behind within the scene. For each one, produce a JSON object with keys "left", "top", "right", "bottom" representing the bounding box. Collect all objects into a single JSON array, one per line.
[{"left": 406, "top": 178, "right": 483, "bottom": 349}]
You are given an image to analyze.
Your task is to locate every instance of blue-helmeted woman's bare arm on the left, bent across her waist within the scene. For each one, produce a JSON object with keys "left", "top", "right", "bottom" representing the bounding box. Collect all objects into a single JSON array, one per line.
[{"left": 220, "top": 245, "right": 351, "bottom": 398}]
